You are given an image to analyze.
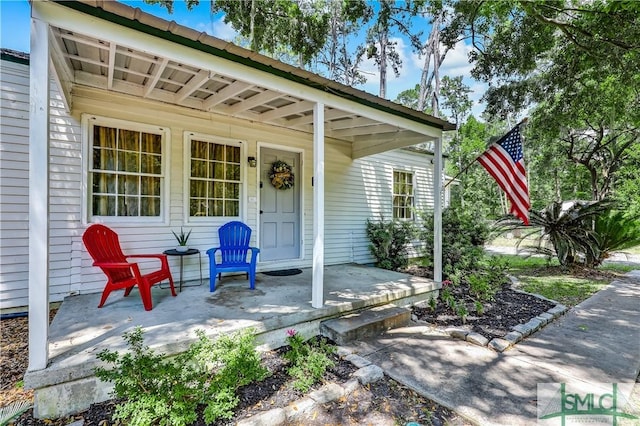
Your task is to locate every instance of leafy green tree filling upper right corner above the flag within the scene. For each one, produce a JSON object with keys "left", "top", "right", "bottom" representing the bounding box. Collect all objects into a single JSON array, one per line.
[{"left": 452, "top": 0, "right": 640, "bottom": 207}]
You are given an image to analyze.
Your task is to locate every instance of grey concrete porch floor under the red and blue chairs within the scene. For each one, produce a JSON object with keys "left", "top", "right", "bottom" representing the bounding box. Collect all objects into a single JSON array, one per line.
[{"left": 25, "top": 264, "right": 438, "bottom": 417}]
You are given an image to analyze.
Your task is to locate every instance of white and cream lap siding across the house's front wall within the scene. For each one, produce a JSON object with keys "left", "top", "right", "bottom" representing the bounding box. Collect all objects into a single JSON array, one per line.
[{"left": 0, "top": 61, "right": 433, "bottom": 309}]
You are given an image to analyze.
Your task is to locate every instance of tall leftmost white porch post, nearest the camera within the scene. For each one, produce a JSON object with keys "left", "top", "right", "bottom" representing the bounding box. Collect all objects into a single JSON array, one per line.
[{"left": 29, "top": 19, "right": 49, "bottom": 370}]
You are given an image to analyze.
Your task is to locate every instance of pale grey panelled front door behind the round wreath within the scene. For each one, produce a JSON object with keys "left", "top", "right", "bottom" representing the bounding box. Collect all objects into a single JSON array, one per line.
[{"left": 260, "top": 148, "right": 302, "bottom": 261}]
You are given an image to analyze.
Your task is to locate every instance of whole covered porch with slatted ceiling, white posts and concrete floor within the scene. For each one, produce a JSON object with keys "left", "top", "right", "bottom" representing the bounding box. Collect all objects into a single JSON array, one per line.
[{"left": 26, "top": 0, "right": 454, "bottom": 380}]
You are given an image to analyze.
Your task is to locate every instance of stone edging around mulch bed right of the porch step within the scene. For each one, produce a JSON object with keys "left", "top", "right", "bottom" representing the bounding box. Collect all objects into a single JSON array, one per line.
[{"left": 446, "top": 276, "right": 569, "bottom": 352}]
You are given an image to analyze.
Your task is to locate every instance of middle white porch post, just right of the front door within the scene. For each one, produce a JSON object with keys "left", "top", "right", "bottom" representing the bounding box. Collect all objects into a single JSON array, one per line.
[{"left": 311, "top": 102, "right": 324, "bottom": 308}]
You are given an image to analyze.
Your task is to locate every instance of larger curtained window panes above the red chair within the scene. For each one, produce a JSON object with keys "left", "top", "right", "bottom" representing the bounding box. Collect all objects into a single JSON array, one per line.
[{"left": 89, "top": 123, "right": 164, "bottom": 217}]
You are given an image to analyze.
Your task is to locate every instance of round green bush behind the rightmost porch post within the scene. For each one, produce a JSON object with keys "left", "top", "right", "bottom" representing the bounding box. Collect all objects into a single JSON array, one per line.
[{"left": 419, "top": 208, "right": 489, "bottom": 275}]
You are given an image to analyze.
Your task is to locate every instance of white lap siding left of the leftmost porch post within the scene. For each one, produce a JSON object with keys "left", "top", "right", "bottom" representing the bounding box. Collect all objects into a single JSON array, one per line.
[{"left": 0, "top": 61, "right": 29, "bottom": 309}]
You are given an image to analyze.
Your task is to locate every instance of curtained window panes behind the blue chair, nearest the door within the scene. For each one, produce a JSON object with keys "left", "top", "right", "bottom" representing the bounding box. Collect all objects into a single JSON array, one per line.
[{"left": 189, "top": 139, "right": 241, "bottom": 217}]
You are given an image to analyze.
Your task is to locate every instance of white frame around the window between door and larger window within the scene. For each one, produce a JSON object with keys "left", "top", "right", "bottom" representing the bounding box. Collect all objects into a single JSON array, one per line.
[{"left": 183, "top": 131, "right": 247, "bottom": 224}]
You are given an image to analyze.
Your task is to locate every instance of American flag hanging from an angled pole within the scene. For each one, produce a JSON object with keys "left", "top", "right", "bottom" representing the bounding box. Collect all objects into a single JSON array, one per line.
[{"left": 478, "top": 125, "right": 531, "bottom": 225}]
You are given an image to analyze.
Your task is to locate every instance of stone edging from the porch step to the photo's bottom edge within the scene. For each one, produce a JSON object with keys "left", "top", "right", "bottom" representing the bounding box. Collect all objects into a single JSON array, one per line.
[{"left": 236, "top": 347, "right": 384, "bottom": 426}]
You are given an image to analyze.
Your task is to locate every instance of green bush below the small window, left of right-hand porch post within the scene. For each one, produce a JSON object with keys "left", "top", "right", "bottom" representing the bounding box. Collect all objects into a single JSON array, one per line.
[{"left": 367, "top": 219, "right": 415, "bottom": 271}]
